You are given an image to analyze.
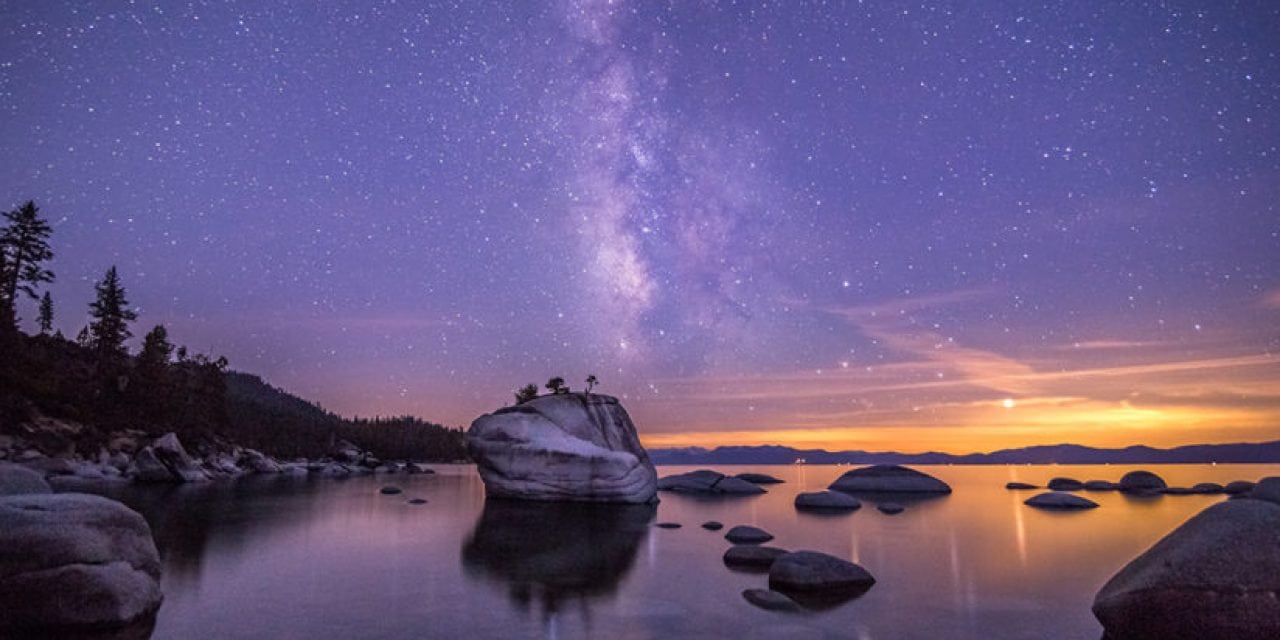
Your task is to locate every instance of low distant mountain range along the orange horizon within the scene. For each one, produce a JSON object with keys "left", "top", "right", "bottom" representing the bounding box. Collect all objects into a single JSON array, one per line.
[{"left": 649, "top": 440, "right": 1280, "bottom": 465}]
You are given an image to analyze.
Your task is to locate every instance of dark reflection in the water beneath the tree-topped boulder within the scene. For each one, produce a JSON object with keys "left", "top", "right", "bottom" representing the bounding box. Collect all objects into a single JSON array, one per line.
[{"left": 462, "top": 499, "right": 657, "bottom": 621}]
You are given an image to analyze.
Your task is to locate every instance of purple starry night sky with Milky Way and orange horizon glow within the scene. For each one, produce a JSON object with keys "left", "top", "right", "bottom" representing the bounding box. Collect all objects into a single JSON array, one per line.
[{"left": 0, "top": 0, "right": 1280, "bottom": 451}]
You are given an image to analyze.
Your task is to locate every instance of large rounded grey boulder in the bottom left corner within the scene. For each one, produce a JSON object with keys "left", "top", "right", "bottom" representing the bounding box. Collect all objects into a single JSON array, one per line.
[{"left": 0, "top": 493, "right": 161, "bottom": 637}]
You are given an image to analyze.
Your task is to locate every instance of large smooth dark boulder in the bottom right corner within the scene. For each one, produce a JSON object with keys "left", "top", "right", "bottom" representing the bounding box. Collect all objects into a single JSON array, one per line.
[{"left": 1093, "top": 499, "right": 1280, "bottom": 640}]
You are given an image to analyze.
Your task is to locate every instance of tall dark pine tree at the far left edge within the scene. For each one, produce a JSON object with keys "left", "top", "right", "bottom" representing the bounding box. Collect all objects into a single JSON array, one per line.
[{"left": 0, "top": 200, "right": 54, "bottom": 333}]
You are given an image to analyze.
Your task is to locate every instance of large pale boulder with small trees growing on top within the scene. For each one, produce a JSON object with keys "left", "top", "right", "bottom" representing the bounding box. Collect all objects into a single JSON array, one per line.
[{"left": 467, "top": 393, "right": 658, "bottom": 503}]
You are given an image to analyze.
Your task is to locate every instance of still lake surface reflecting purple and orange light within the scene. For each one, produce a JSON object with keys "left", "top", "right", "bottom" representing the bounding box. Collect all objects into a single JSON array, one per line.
[{"left": 79, "top": 465, "right": 1280, "bottom": 640}]
